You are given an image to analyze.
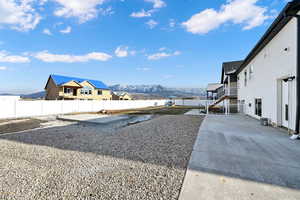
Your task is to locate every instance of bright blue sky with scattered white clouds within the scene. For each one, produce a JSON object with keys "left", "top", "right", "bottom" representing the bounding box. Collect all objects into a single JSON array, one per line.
[{"left": 0, "top": 0, "right": 287, "bottom": 93}]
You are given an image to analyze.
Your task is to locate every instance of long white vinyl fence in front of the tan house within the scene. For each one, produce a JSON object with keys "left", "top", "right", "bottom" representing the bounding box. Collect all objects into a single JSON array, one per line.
[{"left": 0, "top": 100, "right": 167, "bottom": 119}]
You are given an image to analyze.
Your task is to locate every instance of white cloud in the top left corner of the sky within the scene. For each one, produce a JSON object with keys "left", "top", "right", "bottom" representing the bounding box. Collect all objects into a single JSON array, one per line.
[{"left": 0, "top": 0, "right": 41, "bottom": 31}]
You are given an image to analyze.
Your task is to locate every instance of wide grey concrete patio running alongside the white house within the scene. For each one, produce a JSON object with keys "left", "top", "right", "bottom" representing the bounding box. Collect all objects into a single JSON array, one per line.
[{"left": 179, "top": 115, "right": 300, "bottom": 200}]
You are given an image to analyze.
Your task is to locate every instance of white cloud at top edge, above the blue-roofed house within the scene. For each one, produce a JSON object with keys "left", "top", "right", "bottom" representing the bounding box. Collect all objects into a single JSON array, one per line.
[{"left": 54, "top": 0, "right": 106, "bottom": 23}]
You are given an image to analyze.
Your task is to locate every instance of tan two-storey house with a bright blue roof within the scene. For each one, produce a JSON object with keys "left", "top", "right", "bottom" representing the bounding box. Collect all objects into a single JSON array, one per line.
[{"left": 45, "top": 75, "right": 112, "bottom": 100}]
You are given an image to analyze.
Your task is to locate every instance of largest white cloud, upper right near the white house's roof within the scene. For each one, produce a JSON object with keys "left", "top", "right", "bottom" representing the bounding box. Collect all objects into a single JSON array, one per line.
[{"left": 182, "top": 0, "right": 270, "bottom": 34}]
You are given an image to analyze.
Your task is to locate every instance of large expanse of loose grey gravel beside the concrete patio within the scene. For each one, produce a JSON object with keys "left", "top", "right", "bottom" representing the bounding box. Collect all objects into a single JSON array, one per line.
[{"left": 0, "top": 115, "right": 202, "bottom": 200}]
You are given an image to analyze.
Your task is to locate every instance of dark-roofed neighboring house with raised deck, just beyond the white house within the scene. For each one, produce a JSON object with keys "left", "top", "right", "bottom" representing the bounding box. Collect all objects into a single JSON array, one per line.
[{"left": 211, "top": 61, "right": 243, "bottom": 113}]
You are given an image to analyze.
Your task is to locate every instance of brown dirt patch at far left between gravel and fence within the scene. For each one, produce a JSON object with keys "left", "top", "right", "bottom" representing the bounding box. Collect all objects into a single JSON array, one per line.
[{"left": 0, "top": 119, "right": 45, "bottom": 134}]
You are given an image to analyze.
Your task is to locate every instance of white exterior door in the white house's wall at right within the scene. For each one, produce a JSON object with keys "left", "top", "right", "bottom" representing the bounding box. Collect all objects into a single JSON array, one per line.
[{"left": 281, "top": 81, "right": 289, "bottom": 128}]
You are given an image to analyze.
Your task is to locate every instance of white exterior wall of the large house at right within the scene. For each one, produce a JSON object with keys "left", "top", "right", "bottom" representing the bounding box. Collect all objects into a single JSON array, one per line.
[{"left": 238, "top": 19, "right": 297, "bottom": 130}]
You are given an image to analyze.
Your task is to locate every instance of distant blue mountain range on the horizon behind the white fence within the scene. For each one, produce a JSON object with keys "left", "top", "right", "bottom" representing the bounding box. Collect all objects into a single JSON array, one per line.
[{"left": 0, "top": 85, "right": 205, "bottom": 99}]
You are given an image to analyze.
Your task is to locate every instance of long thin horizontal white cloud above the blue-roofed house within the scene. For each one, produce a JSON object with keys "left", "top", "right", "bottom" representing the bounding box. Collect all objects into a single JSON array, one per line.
[{"left": 34, "top": 51, "right": 112, "bottom": 63}]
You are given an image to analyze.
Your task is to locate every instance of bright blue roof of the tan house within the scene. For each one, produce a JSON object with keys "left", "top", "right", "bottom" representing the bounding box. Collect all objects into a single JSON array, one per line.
[{"left": 50, "top": 74, "right": 109, "bottom": 89}]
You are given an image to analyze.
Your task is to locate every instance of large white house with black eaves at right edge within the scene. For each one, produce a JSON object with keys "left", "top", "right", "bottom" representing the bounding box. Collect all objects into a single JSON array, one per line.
[{"left": 237, "top": 0, "right": 300, "bottom": 138}]
